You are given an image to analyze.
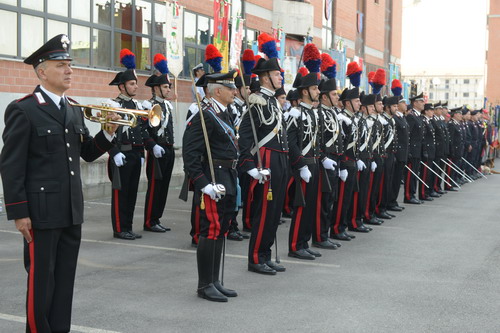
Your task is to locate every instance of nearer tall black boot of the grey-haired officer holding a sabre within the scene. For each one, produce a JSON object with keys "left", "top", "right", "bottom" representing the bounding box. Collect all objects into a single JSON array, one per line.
[{"left": 196, "top": 237, "right": 227, "bottom": 302}]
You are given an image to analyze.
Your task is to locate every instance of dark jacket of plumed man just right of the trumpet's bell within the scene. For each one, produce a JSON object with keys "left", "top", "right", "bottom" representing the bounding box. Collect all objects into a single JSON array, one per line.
[{"left": 142, "top": 97, "right": 174, "bottom": 150}]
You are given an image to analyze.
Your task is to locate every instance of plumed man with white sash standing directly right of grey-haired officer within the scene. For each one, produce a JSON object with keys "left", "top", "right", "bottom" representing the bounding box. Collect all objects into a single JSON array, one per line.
[{"left": 239, "top": 34, "right": 288, "bottom": 275}]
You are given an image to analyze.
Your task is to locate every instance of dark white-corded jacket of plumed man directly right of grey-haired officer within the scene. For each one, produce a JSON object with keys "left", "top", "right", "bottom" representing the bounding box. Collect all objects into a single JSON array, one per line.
[{"left": 238, "top": 87, "right": 288, "bottom": 172}]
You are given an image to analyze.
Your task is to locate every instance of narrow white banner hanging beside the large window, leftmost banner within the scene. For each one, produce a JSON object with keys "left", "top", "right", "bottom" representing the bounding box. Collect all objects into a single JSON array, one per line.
[{"left": 165, "top": 1, "right": 184, "bottom": 77}]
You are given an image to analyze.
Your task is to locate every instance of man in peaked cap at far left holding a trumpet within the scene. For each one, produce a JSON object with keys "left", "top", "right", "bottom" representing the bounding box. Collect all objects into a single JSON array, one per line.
[{"left": 0, "top": 35, "right": 120, "bottom": 333}]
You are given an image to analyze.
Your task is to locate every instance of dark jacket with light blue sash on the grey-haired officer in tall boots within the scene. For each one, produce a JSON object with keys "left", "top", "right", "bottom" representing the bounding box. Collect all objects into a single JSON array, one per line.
[{"left": 182, "top": 96, "right": 239, "bottom": 195}]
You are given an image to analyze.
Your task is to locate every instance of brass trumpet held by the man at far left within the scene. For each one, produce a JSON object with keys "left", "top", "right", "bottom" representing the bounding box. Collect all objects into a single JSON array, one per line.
[{"left": 71, "top": 103, "right": 162, "bottom": 127}]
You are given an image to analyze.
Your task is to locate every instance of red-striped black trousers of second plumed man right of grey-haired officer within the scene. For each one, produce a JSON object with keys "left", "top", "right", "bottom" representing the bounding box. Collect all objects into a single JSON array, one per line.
[{"left": 288, "top": 163, "right": 321, "bottom": 251}]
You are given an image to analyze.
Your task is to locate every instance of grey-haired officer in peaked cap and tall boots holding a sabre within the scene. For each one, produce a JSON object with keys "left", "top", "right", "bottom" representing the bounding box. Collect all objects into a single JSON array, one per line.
[{"left": 182, "top": 71, "right": 239, "bottom": 302}]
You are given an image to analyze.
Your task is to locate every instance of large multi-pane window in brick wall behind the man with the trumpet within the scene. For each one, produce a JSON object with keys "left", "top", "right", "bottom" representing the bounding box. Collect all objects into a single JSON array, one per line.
[{"left": 0, "top": 0, "right": 168, "bottom": 71}]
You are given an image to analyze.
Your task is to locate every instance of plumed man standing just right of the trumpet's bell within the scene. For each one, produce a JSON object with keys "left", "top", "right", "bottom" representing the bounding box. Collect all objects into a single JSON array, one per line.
[{"left": 143, "top": 53, "right": 175, "bottom": 232}]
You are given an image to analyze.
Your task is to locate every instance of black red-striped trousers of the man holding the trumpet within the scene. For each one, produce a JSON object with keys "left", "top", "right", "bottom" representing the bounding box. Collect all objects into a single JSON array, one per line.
[{"left": 24, "top": 225, "right": 82, "bottom": 333}]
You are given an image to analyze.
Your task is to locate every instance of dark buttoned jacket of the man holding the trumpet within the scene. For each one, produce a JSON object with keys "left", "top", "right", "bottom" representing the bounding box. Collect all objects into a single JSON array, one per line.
[{"left": 0, "top": 87, "right": 113, "bottom": 229}]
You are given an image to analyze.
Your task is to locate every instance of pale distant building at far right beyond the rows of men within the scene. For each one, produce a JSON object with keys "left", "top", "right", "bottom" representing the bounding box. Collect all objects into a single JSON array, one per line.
[{"left": 403, "top": 73, "right": 484, "bottom": 109}]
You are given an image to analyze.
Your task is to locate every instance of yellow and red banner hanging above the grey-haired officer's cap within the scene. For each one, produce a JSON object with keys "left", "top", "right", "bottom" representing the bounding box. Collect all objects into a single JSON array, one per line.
[{"left": 214, "top": 0, "right": 230, "bottom": 72}]
